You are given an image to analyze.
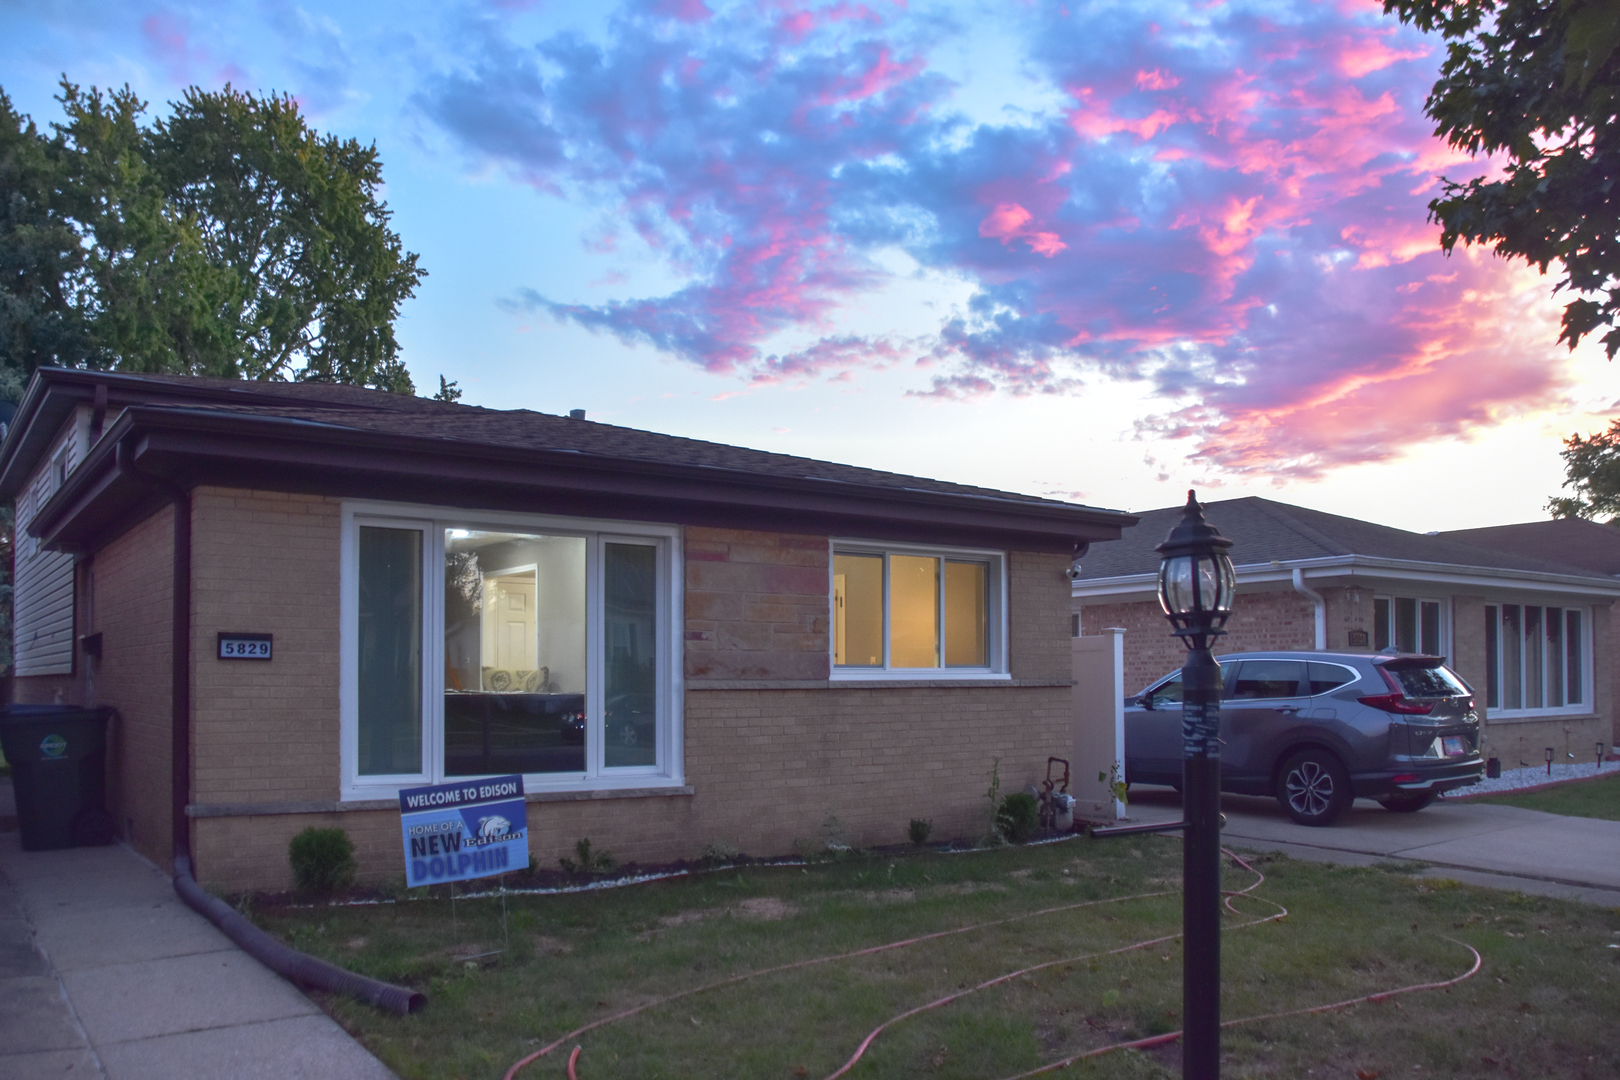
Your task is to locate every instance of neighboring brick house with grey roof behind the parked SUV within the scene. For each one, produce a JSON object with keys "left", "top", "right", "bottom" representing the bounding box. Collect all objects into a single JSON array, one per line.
[{"left": 1072, "top": 499, "right": 1620, "bottom": 769}]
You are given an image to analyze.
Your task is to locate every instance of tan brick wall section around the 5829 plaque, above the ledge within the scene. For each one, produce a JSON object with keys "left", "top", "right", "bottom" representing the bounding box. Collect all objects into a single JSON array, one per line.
[{"left": 191, "top": 487, "right": 342, "bottom": 809}]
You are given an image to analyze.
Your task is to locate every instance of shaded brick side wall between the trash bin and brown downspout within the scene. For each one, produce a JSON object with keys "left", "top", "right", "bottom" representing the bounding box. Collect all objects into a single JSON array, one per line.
[{"left": 81, "top": 507, "right": 175, "bottom": 866}]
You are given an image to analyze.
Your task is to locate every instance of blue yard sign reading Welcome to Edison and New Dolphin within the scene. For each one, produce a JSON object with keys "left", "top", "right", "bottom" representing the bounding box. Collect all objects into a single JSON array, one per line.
[{"left": 400, "top": 776, "right": 528, "bottom": 886}]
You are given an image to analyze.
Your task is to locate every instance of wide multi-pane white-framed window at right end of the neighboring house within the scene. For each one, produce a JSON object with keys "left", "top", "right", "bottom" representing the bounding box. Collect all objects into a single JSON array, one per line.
[{"left": 1486, "top": 604, "right": 1591, "bottom": 714}]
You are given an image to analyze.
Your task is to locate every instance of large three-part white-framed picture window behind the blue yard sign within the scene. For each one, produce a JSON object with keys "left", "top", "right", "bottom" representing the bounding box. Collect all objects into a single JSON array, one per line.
[{"left": 343, "top": 507, "right": 679, "bottom": 797}]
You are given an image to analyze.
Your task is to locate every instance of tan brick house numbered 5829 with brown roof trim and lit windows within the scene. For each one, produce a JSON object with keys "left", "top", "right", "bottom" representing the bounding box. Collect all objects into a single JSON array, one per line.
[{"left": 0, "top": 369, "right": 1134, "bottom": 889}]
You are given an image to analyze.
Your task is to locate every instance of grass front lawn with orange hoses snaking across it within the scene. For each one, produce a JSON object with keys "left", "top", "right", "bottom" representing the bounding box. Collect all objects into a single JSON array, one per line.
[{"left": 251, "top": 837, "right": 1620, "bottom": 1080}]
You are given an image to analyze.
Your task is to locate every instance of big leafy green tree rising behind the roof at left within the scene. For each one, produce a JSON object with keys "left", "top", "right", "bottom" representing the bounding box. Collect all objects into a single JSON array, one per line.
[{"left": 0, "top": 79, "right": 426, "bottom": 393}]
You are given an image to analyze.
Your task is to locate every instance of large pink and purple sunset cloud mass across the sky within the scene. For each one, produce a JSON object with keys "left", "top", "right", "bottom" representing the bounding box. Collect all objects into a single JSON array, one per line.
[{"left": 431, "top": 0, "right": 1557, "bottom": 474}]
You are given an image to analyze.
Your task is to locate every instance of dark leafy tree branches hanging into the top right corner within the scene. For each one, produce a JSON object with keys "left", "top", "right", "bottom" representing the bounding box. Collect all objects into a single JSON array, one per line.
[{"left": 1383, "top": 0, "right": 1620, "bottom": 359}]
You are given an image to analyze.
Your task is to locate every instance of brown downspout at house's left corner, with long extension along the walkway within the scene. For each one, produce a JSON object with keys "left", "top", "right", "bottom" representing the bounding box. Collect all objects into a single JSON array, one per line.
[{"left": 117, "top": 442, "right": 428, "bottom": 1015}]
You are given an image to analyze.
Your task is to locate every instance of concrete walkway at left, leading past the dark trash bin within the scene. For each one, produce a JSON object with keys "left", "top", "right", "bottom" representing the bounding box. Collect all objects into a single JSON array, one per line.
[{"left": 0, "top": 784, "right": 394, "bottom": 1080}]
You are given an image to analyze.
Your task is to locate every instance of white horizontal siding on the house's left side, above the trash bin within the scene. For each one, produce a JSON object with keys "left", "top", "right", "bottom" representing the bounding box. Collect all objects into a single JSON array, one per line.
[{"left": 11, "top": 421, "right": 83, "bottom": 675}]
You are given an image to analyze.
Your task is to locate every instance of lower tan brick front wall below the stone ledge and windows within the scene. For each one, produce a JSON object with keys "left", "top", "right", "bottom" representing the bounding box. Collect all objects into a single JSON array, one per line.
[{"left": 193, "top": 687, "right": 1071, "bottom": 891}]
